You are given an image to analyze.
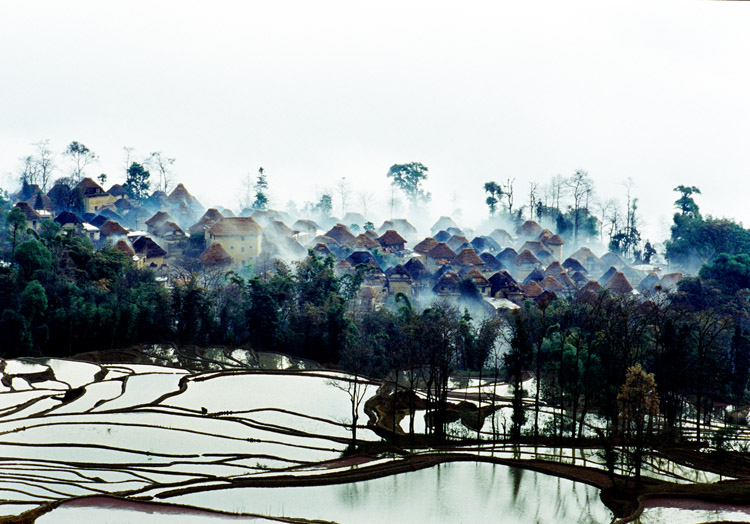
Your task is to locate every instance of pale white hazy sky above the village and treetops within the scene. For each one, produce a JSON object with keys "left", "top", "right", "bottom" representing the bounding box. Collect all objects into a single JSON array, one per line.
[{"left": 0, "top": 0, "right": 750, "bottom": 243}]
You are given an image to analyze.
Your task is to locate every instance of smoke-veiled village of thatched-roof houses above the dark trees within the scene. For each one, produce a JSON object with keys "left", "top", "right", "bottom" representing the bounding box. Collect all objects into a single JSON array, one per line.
[{"left": 7, "top": 178, "right": 682, "bottom": 309}]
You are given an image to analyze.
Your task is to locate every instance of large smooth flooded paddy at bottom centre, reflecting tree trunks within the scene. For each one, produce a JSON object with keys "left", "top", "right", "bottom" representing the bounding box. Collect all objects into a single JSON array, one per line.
[{"left": 169, "top": 462, "right": 612, "bottom": 524}]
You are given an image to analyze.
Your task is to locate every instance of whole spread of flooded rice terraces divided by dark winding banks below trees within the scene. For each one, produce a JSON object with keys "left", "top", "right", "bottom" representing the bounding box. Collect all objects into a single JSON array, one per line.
[{"left": 0, "top": 354, "right": 750, "bottom": 524}]
